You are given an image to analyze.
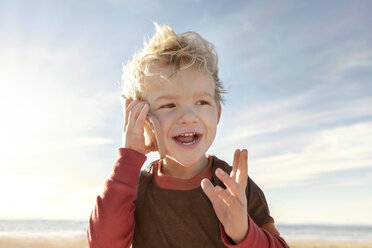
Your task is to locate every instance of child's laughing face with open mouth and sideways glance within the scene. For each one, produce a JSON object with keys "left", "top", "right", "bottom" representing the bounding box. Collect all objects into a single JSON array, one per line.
[{"left": 144, "top": 67, "right": 220, "bottom": 167}]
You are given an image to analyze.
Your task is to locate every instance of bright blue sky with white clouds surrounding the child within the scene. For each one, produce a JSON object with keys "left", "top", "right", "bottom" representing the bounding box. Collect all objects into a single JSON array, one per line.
[{"left": 0, "top": 0, "right": 372, "bottom": 224}]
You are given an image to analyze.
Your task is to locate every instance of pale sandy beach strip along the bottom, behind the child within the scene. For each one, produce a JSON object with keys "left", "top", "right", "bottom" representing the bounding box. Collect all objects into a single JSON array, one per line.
[{"left": 0, "top": 237, "right": 372, "bottom": 248}]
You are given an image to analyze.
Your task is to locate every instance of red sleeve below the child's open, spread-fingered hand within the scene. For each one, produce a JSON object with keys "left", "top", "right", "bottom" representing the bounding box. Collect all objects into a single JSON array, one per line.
[{"left": 220, "top": 216, "right": 289, "bottom": 248}]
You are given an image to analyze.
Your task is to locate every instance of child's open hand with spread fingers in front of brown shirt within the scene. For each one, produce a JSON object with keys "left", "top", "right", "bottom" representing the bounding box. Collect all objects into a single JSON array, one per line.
[{"left": 201, "top": 149, "right": 248, "bottom": 244}]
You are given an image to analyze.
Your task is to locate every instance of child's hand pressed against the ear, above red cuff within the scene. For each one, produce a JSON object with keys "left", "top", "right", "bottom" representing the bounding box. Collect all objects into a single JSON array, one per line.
[{"left": 123, "top": 99, "right": 151, "bottom": 154}]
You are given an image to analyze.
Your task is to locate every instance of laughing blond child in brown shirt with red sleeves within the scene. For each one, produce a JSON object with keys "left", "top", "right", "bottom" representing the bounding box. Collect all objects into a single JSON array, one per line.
[{"left": 87, "top": 24, "right": 288, "bottom": 248}]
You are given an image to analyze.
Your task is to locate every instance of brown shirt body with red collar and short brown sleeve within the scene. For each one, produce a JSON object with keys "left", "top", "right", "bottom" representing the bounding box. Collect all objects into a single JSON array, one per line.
[{"left": 132, "top": 156, "right": 274, "bottom": 248}]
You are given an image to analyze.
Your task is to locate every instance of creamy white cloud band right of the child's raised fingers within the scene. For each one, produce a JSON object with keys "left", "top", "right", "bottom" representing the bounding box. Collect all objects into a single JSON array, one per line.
[{"left": 252, "top": 122, "right": 372, "bottom": 187}]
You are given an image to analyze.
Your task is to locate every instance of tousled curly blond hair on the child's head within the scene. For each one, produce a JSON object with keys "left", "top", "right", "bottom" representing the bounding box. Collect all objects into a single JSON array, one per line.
[{"left": 122, "top": 22, "right": 226, "bottom": 105}]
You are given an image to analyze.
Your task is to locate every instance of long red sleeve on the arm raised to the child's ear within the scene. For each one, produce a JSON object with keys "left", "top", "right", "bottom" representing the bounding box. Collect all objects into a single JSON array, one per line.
[{"left": 87, "top": 148, "right": 146, "bottom": 248}]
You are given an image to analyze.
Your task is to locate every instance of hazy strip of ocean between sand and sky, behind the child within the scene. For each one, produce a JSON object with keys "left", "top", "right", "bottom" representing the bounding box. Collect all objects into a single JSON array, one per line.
[{"left": 0, "top": 220, "right": 372, "bottom": 242}]
